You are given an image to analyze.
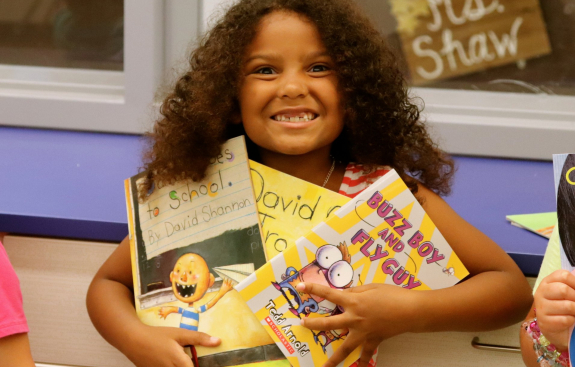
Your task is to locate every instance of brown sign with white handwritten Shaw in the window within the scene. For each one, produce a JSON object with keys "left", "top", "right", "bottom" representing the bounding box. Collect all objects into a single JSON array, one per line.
[{"left": 390, "top": 0, "right": 551, "bottom": 85}]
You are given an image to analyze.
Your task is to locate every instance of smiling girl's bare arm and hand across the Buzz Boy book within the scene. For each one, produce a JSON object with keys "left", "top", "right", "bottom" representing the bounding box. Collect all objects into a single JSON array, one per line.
[{"left": 304, "top": 185, "right": 532, "bottom": 367}]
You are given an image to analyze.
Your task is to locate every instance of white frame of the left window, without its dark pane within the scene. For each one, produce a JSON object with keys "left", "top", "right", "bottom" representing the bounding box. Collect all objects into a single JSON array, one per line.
[{"left": 0, "top": 0, "right": 166, "bottom": 133}]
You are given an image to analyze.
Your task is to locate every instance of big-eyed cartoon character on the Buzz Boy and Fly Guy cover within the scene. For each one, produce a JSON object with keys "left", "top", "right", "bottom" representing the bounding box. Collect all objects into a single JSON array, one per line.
[{"left": 272, "top": 242, "right": 353, "bottom": 317}]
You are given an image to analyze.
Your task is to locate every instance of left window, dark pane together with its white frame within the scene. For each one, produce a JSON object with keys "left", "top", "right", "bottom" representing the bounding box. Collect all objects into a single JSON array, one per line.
[{"left": 0, "top": 0, "right": 199, "bottom": 133}]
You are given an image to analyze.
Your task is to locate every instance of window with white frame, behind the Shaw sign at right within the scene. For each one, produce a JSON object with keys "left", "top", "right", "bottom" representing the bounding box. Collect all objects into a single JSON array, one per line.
[{"left": 356, "top": 0, "right": 575, "bottom": 160}]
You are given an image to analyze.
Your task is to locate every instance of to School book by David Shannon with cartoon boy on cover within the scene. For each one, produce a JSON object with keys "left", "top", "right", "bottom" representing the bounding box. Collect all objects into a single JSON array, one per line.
[{"left": 125, "top": 137, "right": 287, "bottom": 367}]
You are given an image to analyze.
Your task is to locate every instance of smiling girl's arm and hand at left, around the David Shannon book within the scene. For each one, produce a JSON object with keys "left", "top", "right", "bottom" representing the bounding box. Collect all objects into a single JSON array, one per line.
[{"left": 86, "top": 237, "right": 220, "bottom": 367}]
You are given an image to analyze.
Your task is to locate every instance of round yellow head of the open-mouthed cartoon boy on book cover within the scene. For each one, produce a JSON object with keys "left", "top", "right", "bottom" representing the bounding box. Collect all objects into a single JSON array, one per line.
[{"left": 170, "top": 253, "right": 215, "bottom": 304}]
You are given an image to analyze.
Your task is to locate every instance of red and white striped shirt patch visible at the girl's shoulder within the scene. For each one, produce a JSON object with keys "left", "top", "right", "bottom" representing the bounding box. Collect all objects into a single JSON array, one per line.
[{"left": 339, "top": 162, "right": 391, "bottom": 198}]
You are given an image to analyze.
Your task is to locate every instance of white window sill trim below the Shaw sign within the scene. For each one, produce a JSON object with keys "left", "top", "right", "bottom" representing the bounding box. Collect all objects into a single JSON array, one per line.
[{"left": 413, "top": 88, "right": 575, "bottom": 160}]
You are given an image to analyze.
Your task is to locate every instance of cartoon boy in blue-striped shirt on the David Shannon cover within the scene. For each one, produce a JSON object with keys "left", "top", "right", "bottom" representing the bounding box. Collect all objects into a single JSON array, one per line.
[{"left": 158, "top": 253, "right": 232, "bottom": 331}]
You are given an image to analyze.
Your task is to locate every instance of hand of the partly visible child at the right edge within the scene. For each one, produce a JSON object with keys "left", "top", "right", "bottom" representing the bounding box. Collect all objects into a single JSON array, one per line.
[{"left": 534, "top": 270, "right": 575, "bottom": 351}]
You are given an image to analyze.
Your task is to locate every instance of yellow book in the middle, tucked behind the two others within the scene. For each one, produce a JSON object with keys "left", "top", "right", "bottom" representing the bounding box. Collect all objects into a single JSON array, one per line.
[{"left": 250, "top": 161, "right": 349, "bottom": 258}]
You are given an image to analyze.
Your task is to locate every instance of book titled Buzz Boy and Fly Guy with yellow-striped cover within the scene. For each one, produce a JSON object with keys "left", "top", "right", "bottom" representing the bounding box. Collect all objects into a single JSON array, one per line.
[{"left": 236, "top": 170, "right": 469, "bottom": 367}]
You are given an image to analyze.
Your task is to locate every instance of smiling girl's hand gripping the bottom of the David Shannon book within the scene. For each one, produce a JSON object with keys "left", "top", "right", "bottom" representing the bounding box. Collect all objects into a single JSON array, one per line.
[{"left": 122, "top": 325, "right": 220, "bottom": 367}]
